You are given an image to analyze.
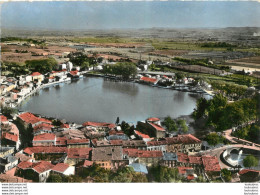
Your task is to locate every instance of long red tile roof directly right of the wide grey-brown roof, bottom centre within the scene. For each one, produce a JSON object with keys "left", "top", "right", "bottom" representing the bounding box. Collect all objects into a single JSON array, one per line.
[{"left": 123, "top": 148, "right": 163, "bottom": 158}]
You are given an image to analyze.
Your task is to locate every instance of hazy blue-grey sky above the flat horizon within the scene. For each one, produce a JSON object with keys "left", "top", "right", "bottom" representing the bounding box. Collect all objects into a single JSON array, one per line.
[{"left": 1, "top": 1, "right": 260, "bottom": 30}]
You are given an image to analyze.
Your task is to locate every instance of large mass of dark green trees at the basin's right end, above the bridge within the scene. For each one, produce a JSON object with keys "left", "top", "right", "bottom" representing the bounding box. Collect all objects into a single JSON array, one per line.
[{"left": 193, "top": 94, "right": 259, "bottom": 131}]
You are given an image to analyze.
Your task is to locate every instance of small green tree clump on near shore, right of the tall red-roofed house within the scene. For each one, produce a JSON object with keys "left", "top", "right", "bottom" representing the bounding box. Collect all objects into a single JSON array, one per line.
[{"left": 162, "top": 116, "right": 189, "bottom": 133}]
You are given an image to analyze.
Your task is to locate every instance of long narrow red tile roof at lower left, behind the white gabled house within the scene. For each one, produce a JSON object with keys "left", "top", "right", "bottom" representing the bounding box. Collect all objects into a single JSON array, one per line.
[{"left": 24, "top": 146, "right": 68, "bottom": 155}]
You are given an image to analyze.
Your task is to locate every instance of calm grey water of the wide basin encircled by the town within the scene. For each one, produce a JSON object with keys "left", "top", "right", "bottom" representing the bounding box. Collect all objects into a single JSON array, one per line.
[{"left": 19, "top": 77, "right": 205, "bottom": 124}]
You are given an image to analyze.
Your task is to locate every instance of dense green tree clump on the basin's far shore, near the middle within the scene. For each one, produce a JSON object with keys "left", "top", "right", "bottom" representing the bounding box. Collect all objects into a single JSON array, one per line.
[{"left": 103, "top": 62, "right": 137, "bottom": 80}]
